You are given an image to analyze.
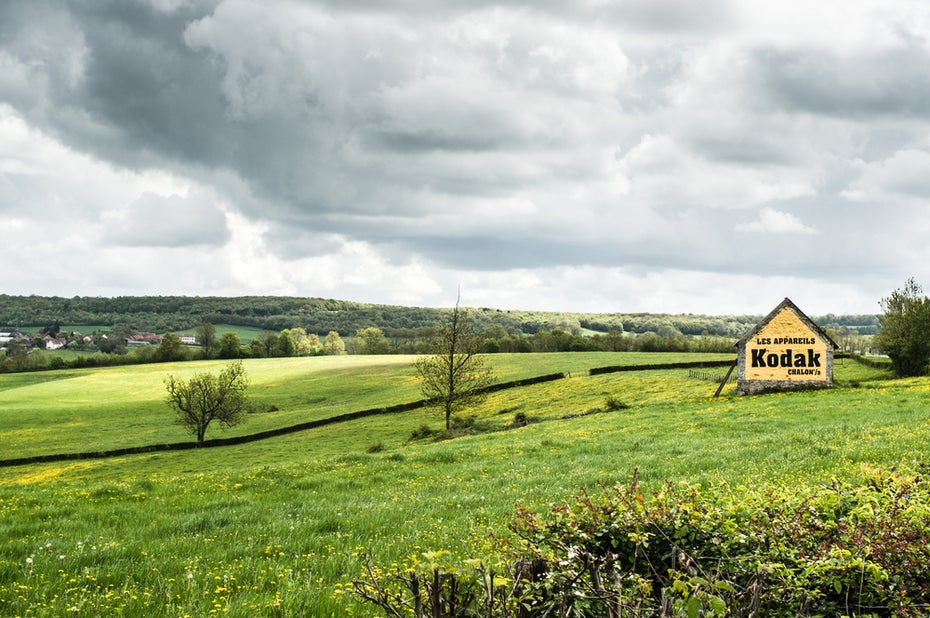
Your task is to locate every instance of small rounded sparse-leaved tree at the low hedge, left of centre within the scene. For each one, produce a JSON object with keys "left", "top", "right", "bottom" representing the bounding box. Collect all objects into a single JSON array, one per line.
[{"left": 165, "top": 361, "right": 250, "bottom": 446}]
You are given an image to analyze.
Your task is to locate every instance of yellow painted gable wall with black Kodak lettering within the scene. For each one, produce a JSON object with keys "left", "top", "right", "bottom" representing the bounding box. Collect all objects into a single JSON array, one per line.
[{"left": 745, "top": 307, "right": 828, "bottom": 381}]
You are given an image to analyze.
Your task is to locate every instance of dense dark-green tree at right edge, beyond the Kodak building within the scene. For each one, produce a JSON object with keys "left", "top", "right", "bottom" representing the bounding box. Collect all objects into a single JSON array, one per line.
[{"left": 875, "top": 277, "right": 930, "bottom": 376}]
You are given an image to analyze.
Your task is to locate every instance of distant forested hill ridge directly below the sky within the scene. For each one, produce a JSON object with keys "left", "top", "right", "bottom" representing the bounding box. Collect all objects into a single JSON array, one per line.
[{"left": 0, "top": 294, "right": 878, "bottom": 338}]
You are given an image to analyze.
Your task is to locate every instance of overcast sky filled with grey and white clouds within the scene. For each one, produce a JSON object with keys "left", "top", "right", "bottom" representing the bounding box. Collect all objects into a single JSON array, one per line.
[{"left": 0, "top": 0, "right": 930, "bottom": 315}]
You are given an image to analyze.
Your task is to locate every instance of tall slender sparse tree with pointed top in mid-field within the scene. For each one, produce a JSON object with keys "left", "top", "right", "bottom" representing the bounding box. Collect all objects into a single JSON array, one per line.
[{"left": 416, "top": 299, "right": 494, "bottom": 430}]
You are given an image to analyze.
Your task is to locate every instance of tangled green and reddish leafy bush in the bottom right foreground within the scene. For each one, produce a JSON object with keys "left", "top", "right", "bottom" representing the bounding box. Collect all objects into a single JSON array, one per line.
[{"left": 351, "top": 469, "right": 930, "bottom": 618}]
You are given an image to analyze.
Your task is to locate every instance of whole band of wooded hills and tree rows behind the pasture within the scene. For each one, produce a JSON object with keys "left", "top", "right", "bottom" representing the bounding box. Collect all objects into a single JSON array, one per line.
[{"left": 0, "top": 294, "right": 879, "bottom": 371}]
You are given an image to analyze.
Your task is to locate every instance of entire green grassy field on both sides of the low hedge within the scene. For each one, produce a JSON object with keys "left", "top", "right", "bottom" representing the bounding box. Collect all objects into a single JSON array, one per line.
[{"left": 0, "top": 353, "right": 930, "bottom": 616}]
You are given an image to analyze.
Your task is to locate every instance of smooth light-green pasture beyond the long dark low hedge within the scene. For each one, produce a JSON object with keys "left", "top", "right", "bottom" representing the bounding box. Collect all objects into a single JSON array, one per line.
[{"left": 0, "top": 352, "right": 727, "bottom": 459}]
